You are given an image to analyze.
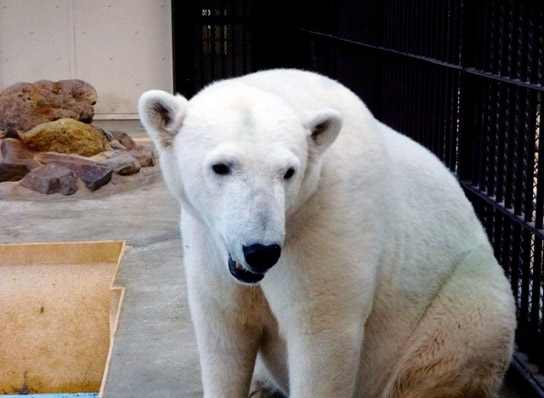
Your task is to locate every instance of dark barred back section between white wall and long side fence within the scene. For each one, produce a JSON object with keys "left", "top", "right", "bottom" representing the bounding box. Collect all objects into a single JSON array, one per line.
[{"left": 172, "top": 0, "right": 300, "bottom": 97}]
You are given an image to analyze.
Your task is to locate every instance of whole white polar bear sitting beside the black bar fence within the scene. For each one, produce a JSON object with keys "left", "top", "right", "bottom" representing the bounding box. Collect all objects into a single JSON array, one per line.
[{"left": 139, "top": 70, "right": 516, "bottom": 398}]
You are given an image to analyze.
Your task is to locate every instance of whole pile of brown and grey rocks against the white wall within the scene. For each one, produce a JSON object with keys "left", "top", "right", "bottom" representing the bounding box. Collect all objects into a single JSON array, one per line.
[{"left": 0, "top": 80, "right": 155, "bottom": 197}]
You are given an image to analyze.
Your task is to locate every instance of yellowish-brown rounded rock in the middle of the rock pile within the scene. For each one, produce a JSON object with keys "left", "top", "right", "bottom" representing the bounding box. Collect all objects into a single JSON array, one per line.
[{"left": 21, "top": 119, "right": 107, "bottom": 156}]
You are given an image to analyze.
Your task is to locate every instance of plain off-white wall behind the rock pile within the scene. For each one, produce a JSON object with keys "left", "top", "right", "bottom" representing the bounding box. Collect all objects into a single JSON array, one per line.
[{"left": 0, "top": 0, "right": 173, "bottom": 119}]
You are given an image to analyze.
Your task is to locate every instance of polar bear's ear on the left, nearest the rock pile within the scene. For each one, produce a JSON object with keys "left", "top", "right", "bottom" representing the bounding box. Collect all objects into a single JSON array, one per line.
[{"left": 138, "top": 90, "right": 187, "bottom": 150}]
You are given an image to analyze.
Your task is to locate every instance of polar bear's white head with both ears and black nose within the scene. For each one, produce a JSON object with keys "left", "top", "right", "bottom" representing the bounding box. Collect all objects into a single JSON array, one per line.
[{"left": 139, "top": 83, "right": 342, "bottom": 284}]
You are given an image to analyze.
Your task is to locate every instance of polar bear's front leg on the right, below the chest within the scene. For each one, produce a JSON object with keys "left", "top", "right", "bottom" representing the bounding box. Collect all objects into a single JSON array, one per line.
[{"left": 262, "top": 255, "right": 374, "bottom": 398}]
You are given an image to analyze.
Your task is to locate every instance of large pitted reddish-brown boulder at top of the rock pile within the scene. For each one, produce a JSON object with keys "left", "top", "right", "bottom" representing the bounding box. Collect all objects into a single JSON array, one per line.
[{"left": 0, "top": 79, "right": 98, "bottom": 131}]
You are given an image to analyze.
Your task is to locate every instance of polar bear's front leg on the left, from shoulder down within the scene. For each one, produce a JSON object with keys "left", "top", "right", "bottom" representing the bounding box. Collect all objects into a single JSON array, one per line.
[{"left": 182, "top": 214, "right": 264, "bottom": 398}]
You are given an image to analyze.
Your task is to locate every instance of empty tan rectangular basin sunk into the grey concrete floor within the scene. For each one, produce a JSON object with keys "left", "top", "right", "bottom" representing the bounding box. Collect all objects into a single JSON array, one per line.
[{"left": 0, "top": 241, "right": 124, "bottom": 394}]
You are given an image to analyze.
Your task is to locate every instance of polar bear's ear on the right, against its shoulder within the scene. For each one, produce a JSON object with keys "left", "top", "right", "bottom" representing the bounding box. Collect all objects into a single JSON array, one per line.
[{"left": 306, "top": 109, "right": 342, "bottom": 153}]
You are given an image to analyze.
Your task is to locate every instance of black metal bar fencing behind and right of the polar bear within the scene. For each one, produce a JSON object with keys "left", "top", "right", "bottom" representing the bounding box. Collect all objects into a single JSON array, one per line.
[{"left": 172, "top": 0, "right": 544, "bottom": 396}]
